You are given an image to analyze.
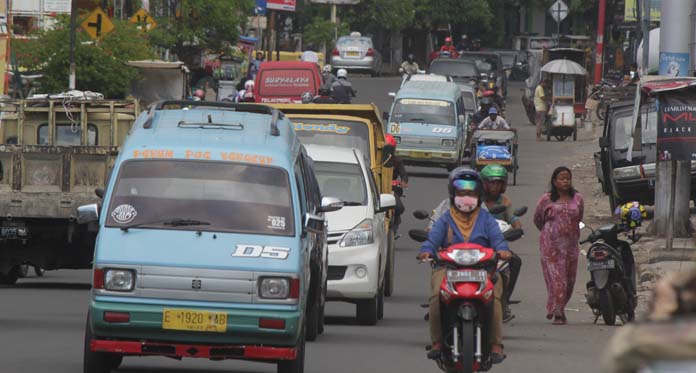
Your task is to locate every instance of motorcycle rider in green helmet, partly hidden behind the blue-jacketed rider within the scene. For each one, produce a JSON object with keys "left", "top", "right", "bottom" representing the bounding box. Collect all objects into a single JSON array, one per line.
[{"left": 481, "top": 164, "right": 522, "bottom": 322}]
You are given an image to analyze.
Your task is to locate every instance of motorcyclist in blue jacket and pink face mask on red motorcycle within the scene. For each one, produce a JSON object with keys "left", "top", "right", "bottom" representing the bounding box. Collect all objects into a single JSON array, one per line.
[{"left": 418, "top": 167, "right": 512, "bottom": 364}]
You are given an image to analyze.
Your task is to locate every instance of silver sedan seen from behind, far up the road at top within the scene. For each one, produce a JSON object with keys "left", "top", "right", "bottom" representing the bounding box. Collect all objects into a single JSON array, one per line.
[{"left": 331, "top": 32, "right": 382, "bottom": 76}]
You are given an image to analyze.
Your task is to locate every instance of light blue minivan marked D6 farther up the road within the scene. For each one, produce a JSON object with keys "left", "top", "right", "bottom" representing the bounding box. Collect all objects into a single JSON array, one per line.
[{"left": 387, "top": 81, "right": 466, "bottom": 170}]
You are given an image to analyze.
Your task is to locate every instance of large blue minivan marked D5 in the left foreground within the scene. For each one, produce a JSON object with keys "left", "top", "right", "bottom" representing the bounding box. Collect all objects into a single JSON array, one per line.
[{"left": 78, "top": 101, "right": 342, "bottom": 373}]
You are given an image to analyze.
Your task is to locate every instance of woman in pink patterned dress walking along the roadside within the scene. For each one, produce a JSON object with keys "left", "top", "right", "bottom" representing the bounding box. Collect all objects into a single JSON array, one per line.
[{"left": 534, "top": 167, "right": 584, "bottom": 325}]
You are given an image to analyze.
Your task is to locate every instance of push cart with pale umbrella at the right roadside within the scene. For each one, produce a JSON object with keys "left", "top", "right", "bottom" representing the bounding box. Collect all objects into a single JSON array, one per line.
[{"left": 541, "top": 59, "right": 587, "bottom": 141}]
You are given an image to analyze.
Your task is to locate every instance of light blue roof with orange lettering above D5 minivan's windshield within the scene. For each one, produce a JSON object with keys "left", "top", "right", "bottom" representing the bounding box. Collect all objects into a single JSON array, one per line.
[{"left": 121, "top": 107, "right": 300, "bottom": 169}]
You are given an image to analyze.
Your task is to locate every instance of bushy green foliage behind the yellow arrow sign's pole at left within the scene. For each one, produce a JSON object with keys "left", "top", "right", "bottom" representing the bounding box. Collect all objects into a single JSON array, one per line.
[{"left": 13, "top": 17, "right": 153, "bottom": 98}]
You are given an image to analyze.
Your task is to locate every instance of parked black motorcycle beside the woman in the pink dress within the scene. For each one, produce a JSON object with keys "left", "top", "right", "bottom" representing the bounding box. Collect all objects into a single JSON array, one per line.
[{"left": 580, "top": 223, "right": 640, "bottom": 325}]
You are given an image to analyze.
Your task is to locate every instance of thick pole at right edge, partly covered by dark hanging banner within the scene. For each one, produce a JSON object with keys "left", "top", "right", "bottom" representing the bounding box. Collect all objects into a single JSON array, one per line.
[{"left": 643, "top": 0, "right": 696, "bottom": 244}]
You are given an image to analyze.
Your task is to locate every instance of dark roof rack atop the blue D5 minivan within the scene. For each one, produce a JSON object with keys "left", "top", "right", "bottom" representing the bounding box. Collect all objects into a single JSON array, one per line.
[{"left": 143, "top": 100, "right": 283, "bottom": 136}]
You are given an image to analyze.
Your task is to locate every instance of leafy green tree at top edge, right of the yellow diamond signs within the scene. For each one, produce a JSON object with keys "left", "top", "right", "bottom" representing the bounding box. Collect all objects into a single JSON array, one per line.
[{"left": 148, "top": 0, "right": 254, "bottom": 65}]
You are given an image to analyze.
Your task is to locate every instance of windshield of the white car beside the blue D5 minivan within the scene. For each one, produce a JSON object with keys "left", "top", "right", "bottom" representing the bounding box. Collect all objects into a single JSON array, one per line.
[{"left": 314, "top": 161, "right": 367, "bottom": 206}]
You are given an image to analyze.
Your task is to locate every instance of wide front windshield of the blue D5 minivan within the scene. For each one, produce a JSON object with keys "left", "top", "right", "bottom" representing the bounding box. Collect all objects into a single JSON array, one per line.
[{"left": 106, "top": 159, "right": 295, "bottom": 236}]
